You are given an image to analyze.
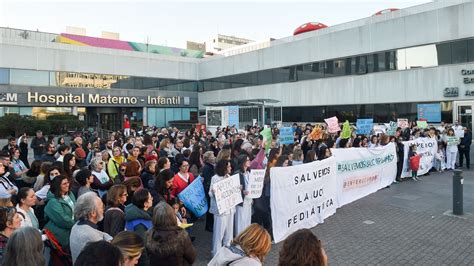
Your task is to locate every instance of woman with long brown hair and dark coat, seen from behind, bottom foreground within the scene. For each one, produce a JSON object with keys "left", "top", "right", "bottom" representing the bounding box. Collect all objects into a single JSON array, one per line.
[{"left": 145, "top": 202, "right": 196, "bottom": 265}]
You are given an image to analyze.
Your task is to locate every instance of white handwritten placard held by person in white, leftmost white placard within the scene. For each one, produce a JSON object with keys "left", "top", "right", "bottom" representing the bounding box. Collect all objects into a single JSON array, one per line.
[{"left": 212, "top": 174, "right": 243, "bottom": 214}]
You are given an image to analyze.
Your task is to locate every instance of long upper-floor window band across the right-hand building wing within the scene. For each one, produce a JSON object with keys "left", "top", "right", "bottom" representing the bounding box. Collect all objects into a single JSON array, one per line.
[{"left": 199, "top": 39, "right": 474, "bottom": 91}]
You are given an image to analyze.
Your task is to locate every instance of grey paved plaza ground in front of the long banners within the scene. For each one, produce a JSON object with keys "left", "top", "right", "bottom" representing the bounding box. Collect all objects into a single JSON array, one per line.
[{"left": 194, "top": 171, "right": 474, "bottom": 265}]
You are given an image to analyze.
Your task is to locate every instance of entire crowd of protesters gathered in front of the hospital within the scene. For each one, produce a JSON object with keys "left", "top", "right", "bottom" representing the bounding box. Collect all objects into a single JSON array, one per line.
[{"left": 0, "top": 119, "right": 472, "bottom": 265}]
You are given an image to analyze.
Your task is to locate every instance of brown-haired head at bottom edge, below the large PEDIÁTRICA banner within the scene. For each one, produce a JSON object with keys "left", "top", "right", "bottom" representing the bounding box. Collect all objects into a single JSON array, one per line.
[{"left": 278, "top": 229, "right": 328, "bottom": 266}]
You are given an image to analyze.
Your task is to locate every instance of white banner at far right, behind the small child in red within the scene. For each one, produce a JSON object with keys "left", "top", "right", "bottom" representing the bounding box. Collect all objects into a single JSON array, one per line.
[{"left": 402, "top": 138, "right": 438, "bottom": 177}]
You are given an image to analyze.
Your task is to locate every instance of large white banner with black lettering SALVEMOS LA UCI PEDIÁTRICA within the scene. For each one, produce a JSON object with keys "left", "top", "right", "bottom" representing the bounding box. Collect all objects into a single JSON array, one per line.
[{"left": 270, "top": 157, "right": 337, "bottom": 242}]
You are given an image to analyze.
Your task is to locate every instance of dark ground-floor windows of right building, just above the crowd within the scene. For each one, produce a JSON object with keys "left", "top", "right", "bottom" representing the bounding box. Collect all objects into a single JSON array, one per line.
[{"left": 283, "top": 102, "right": 453, "bottom": 123}]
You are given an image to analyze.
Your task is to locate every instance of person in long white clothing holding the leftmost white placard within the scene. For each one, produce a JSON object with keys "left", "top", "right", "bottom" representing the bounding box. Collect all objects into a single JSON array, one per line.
[{"left": 209, "top": 160, "right": 235, "bottom": 256}]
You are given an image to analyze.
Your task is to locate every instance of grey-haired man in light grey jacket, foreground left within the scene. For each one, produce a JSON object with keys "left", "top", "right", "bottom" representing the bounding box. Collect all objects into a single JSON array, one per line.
[{"left": 70, "top": 192, "right": 112, "bottom": 262}]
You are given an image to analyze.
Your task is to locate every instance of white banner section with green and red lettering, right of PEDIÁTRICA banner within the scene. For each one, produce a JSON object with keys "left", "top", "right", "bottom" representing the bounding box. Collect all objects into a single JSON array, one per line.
[{"left": 331, "top": 143, "right": 397, "bottom": 207}]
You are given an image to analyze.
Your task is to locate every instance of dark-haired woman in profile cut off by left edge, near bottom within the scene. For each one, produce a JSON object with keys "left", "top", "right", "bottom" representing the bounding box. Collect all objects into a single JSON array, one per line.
[{"left": 0, "top": 207, "right": 22, "bottom": 260}]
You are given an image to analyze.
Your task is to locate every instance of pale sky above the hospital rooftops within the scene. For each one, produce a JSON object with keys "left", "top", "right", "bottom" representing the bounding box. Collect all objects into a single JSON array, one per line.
[{"left": 0, "top": 0, "right": 431, "bottom": 48}]
